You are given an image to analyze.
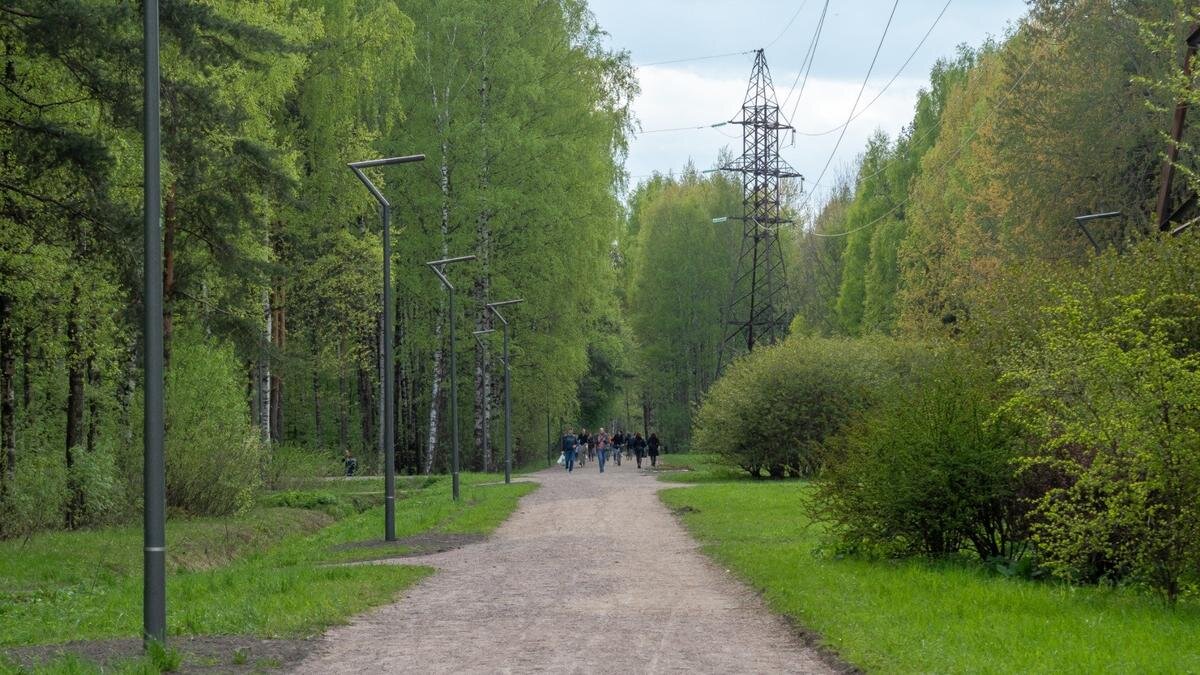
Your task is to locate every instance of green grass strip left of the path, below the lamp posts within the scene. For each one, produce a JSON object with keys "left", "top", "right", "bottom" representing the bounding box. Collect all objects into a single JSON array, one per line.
[{"left": 0, "top": 473, "right": 535, "bottom": 646}]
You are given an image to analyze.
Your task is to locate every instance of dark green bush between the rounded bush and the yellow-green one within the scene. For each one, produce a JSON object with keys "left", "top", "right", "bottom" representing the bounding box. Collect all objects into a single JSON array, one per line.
[{"left": 811, "top": 348, "right": 1027, "bottom": 561}]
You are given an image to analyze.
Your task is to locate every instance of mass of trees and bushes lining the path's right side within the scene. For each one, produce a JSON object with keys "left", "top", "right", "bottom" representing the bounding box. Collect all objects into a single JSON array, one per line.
[{"left": 667, "top": 0, "right": 1200, "bottom": 601}]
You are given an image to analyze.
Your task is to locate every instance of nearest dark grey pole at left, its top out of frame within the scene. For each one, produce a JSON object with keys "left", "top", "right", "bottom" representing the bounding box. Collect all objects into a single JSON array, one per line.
[{"left": 142, "top": 0, "right": 167, "bottom": 646}]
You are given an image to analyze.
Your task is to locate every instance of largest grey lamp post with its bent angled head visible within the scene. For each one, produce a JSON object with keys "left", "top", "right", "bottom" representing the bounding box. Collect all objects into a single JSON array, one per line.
[{"left": 347, "top": 155, "right": 425, "bottom": 542}]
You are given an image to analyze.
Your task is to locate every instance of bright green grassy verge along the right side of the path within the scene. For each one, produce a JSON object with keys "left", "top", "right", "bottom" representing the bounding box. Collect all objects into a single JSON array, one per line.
[{"left": 662, "top": 468, "right": 1200, "bottom": 673}]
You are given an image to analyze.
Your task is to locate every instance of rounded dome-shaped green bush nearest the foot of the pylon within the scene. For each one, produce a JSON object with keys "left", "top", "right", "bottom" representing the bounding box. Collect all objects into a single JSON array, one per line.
[{"left": 694, "top": 336, "right": 914, "bottom": 478}]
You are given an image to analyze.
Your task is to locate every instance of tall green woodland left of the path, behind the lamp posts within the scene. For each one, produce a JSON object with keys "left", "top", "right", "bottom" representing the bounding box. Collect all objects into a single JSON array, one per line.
[{"left": 0, "top": 0, "right": 636, "bottom": 537}]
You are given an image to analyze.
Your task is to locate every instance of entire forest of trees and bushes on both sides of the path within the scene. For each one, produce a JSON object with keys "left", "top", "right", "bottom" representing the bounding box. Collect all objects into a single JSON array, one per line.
[{"left": 7, "top": 0, "right": 1200, "bottom": 601}]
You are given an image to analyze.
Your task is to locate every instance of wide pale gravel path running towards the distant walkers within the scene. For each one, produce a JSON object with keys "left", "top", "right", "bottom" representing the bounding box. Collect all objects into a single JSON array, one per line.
[{"left": 296, "top": 454, "right": 830, "bottom": 674}]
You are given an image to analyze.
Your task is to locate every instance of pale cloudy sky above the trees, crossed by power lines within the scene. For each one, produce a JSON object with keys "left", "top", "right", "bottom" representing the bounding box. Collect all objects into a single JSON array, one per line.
[{"left": 589, "top": 0, "right": 1026, "bottom": 205}]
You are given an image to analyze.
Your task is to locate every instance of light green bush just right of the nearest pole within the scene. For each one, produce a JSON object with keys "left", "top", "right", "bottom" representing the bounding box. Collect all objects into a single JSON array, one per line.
[{"left": 154, "top": 338, "right": 266, "bottom": 515}]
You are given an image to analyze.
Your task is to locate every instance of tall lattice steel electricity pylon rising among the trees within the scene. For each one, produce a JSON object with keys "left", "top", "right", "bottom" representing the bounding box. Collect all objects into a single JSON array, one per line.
[{"left": 716, "top": 49, "right": 803, "bottom": 371}]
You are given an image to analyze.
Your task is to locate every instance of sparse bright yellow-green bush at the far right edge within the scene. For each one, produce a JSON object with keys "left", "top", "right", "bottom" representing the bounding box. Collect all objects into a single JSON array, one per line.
[{"left": 1007, "top": 283, "right": 1200, "bottom": 601}]
